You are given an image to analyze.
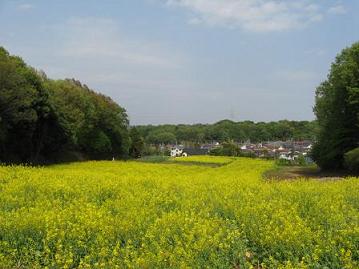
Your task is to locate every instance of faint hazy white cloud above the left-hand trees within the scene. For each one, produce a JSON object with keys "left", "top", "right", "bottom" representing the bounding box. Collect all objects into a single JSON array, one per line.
[{"left": 61, "top": 18, "right": 184, "bottom": 68}]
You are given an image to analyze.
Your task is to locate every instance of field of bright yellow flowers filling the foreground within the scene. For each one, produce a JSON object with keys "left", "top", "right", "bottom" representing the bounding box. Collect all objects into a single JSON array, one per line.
[{"left": 0, "top": 157, "right": 359, "bottom": 269}]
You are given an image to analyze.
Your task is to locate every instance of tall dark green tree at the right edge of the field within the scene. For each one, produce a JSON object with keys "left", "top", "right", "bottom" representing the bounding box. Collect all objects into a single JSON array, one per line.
[{"left": 313, "top": 43, "right": 359, "bottom": 169}]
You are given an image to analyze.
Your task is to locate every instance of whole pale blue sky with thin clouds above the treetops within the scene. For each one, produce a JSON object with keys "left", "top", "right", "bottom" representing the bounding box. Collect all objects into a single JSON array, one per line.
[{"left": 0, "top": 0, "right": 359, "bottom": 125}]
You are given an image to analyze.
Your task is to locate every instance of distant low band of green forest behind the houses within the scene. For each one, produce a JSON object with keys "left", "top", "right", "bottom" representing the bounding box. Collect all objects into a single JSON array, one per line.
[{"left": 136, "top": 120, "right": 317, "bottom": 144}]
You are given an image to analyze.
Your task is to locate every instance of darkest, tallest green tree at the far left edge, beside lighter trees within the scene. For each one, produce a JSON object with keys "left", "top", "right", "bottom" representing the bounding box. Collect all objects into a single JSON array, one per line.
[{"left": 0, "top": 48, "right": 64, "bottom": 162}]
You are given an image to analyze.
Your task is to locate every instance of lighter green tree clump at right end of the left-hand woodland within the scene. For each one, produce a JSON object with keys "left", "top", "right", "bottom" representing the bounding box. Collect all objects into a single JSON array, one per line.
[{"left": 47, "top": 79, "right": 130, "bottom": 159}]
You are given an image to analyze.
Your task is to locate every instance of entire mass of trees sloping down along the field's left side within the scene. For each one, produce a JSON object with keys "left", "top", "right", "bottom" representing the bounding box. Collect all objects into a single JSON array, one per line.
[{"left": 0, "top": 47, "right": 130, "bottom": 163}]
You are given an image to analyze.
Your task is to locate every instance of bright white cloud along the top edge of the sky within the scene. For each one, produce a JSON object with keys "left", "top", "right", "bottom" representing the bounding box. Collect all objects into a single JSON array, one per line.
[{"left": 166, "top": 0, "right": 348, "bottom": 32}]
